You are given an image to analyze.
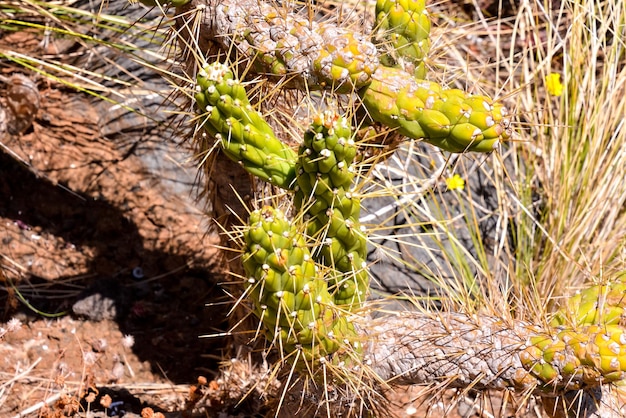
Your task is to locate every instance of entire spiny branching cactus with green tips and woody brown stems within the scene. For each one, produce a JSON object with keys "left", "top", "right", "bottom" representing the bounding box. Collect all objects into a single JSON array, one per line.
[{"left": 168, "top": 0, "right": 626, "bottom": 414}]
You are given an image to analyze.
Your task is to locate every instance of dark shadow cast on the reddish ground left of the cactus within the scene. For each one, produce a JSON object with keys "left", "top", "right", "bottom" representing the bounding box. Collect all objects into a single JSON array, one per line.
[{"left": 0, "top": 136, "right": 226, "bottom": 383}]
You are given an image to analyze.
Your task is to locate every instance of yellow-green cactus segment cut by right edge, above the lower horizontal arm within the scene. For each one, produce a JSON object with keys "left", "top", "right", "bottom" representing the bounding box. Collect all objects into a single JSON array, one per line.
[{"left": 551, "top": 280, "right": 626, "bottom": 327}]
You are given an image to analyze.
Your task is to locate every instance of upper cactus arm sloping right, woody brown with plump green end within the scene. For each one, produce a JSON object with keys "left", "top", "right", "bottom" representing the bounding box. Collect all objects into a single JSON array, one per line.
[{"left": 197, "top": 0, "right": 511, "bottom": 152}]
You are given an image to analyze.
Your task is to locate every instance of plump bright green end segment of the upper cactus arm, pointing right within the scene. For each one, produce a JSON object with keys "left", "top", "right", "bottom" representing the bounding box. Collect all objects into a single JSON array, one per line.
[{"left": 360, "top": 66, "right": 512, "bottom": 152}]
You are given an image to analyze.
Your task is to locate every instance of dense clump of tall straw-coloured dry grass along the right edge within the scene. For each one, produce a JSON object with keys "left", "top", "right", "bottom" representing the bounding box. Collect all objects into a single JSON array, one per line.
[{"left": 508, "top": 1, "right": 626, "bottom": 299}]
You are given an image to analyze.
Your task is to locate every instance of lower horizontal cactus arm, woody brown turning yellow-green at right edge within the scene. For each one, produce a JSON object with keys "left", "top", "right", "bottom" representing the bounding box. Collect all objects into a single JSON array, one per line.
[{"left": 361, "top": 312, "right": 626, "bottom": 396}]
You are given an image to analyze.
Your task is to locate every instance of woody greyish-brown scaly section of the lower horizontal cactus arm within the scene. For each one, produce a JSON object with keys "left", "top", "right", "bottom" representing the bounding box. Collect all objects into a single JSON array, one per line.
[{"left": 363, "top": 312, "right": 541, "bottom": 390}]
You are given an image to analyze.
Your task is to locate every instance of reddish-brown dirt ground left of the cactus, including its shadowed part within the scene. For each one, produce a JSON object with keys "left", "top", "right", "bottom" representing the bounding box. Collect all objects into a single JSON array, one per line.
[{"left": 0, "top": 1, "right": 533, "bottom": 417}]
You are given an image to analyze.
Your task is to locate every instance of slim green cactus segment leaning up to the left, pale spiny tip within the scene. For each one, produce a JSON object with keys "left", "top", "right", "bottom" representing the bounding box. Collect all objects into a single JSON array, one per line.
[{"left": 195, "top": 62, "right": 297, "bottom": 189}]
